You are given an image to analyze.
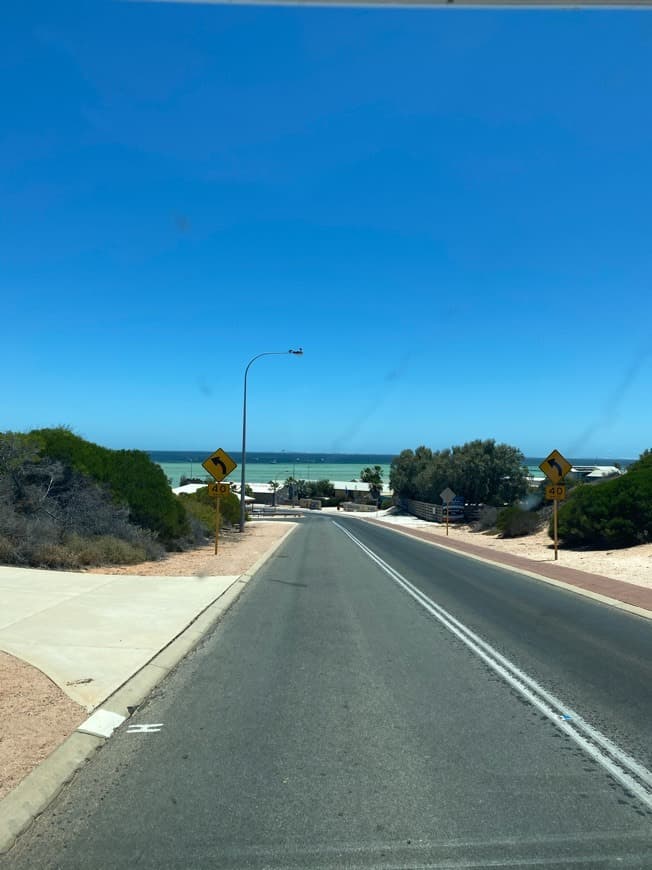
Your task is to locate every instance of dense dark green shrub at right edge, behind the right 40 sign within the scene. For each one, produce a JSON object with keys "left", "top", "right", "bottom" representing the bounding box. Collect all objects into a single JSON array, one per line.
[{"left": 549, "top": 454, "right": 652, "bottom": 549}]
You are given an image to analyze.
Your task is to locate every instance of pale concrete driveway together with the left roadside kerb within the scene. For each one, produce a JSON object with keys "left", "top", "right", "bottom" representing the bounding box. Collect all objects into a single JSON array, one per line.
[{"left": 0, "top": 525, "right": 296, "bottom": 854}]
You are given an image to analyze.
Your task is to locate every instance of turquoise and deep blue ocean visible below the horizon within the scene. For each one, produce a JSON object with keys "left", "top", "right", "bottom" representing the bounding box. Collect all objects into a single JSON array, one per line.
[{"left": 148, "top": 450, "right": 632, "bottom": 486}]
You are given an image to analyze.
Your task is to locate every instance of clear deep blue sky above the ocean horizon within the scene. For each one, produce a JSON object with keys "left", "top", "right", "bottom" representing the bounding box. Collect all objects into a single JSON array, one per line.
[{"left": 5, "top": 0, "right": 652, "bottom": 457}]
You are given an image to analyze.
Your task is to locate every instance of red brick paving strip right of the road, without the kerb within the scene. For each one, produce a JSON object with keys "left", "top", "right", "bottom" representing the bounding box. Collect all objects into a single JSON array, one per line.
[{"left": 365, "top": 519, "right": 652, "bottom": 612}]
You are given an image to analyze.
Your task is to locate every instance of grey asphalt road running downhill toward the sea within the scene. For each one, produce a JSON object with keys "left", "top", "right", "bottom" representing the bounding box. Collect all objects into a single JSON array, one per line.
[{"left": 5, "top": 517, "right": 652, "bottom": 870}]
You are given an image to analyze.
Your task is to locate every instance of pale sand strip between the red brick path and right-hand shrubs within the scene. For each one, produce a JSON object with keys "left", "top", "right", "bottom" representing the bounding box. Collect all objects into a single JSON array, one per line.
[{"left": 362, "top": 511, "right": 652, "bottom": 588}]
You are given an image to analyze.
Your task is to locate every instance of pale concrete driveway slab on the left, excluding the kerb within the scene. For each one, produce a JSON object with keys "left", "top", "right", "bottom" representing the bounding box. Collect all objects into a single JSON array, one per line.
[{"left": 0, "top": 567, "right": 238, "bottom": 711}]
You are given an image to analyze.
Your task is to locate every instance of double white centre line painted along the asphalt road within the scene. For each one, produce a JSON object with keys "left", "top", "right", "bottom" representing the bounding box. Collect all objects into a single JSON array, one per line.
[{"left": 333, "top": 520, "right": 652, "bottom": 809}]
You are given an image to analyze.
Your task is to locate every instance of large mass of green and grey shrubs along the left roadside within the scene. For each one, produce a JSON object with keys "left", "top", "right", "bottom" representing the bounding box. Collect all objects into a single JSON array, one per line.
[{"left": 0, "top": 427, "right": 239, "bottom": 570}]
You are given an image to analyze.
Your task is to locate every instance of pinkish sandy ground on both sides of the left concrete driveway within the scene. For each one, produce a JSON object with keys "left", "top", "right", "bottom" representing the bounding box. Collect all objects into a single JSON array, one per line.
[{"left": 0, "top": 521, "right": 292, "bottom": 799}]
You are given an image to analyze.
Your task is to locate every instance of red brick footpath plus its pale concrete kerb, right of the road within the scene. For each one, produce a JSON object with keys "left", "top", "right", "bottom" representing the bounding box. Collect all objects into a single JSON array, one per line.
[{"left": 348, "top": 514, "right": 652, "bottom": 618}]
